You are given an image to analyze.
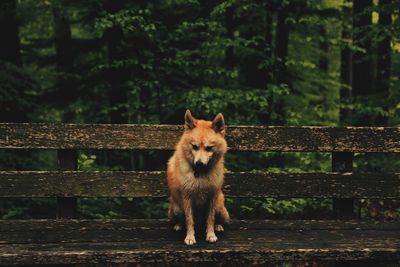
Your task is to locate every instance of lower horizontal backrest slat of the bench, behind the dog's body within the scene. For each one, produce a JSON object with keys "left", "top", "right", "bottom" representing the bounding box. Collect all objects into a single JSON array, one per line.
[{"left": 0, "top": 171, "right": 400, "bottom": 198}]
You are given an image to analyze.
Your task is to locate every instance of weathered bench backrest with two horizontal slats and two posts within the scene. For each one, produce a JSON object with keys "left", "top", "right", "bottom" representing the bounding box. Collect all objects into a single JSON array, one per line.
[{"left": 0, "top": 123, "right": 400, "bottom": 220}]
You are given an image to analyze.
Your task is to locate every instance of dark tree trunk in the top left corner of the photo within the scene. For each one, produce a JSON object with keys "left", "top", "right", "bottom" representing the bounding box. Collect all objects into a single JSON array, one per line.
[{"left": 0, "top": 0, "right": 22, "bottom": 67}]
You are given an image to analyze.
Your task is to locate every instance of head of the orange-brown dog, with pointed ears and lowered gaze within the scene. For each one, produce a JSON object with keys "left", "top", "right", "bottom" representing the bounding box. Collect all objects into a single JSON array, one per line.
[{"left": 183, "top": 110, "right": 227, "bottom": 177}]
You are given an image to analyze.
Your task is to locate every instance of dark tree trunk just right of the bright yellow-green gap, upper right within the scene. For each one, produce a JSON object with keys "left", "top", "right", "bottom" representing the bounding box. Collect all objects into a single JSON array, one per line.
[{"left": 375, "top": 0, "right": 392, "bottom": 126}]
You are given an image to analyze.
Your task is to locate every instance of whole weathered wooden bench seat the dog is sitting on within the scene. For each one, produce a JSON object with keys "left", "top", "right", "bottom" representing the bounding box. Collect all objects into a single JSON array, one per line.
[{"left": 0, "top": 219, "right": 400, "bottom": 265}]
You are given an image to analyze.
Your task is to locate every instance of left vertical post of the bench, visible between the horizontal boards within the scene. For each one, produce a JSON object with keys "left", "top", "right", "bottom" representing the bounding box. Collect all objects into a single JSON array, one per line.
[{"left": 57, "top": 149, "right": 78, "bottom": 219}]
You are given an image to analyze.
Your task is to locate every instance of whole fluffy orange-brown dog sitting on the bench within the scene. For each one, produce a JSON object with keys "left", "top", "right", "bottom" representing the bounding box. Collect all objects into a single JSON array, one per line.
[{"left": 167, "top": 110, "right": 230, "bottom": 245}]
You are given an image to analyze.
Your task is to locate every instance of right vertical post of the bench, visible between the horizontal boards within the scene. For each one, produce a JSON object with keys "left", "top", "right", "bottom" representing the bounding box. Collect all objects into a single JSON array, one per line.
[{"left": 332, "top": 152, "right": 355, "bottom": 219}]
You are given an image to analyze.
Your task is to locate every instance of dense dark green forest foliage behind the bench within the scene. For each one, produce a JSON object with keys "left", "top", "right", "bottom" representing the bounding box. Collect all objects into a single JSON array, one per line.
[{"left": 0, "top": 0, "right": 400, "bottom": 221}]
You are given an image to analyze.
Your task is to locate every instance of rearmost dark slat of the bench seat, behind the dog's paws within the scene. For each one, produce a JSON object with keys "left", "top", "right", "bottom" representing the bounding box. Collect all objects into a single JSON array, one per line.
[{"left": 0, "top": 219, "right": 400, "bottom": 232}]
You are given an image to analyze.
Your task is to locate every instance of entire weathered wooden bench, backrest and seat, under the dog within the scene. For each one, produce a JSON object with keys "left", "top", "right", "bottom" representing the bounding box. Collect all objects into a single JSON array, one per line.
[{"left": 0, "top": 123, "right": 400, "bottom": 265}]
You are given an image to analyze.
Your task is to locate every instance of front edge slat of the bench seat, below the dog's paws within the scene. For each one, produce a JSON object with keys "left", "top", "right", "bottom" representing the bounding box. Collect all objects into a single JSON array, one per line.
[{"left": 0, "top": 242, "right": 400, "bottom": 265}]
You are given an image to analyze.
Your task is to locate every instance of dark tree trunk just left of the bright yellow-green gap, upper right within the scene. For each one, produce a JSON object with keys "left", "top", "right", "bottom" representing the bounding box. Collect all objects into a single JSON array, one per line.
[{"left": 352, "top": 0, "right": 373, "bottom": 126}]
